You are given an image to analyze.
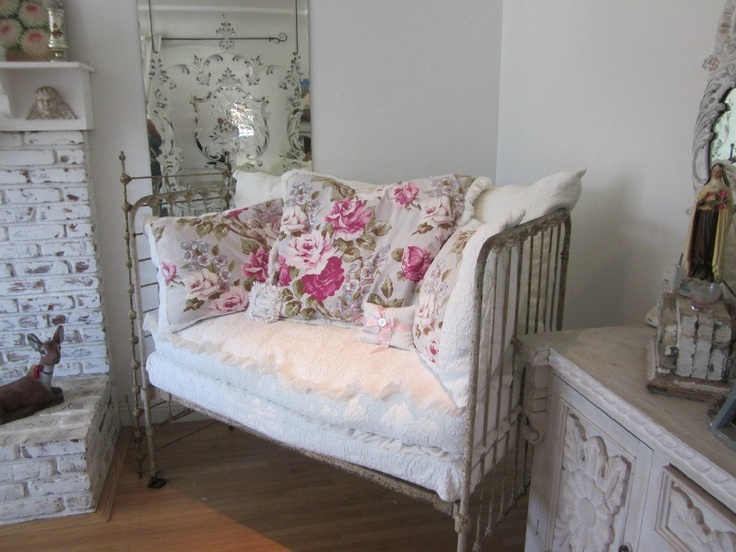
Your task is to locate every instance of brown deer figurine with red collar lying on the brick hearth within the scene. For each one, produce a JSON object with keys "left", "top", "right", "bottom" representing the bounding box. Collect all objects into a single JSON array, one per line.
[{"left": 0, "top": 326, "right": 64, "bottom": 424}]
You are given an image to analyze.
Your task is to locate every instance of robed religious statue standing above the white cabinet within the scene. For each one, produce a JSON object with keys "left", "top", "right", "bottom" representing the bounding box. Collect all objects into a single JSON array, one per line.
[{"left": 685, "top": 163, "right": 734, "bottom": 282}]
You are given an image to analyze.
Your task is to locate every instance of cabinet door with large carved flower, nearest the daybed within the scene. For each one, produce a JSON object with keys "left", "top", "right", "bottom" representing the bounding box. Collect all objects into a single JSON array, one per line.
[{"left": 530, "top": 378, "right": 651, "bottom": 552}]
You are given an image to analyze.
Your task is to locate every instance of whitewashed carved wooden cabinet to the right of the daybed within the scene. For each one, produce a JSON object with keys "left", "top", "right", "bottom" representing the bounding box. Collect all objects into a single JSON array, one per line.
[{"left": 521, "top": 326, "right": 736, "bottom": 552}]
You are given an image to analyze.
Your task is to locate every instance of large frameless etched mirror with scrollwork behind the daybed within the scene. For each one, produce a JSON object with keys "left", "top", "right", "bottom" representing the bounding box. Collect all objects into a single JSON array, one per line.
[{"left": 138, "top": 0, "right": 311, "bottom": 191}]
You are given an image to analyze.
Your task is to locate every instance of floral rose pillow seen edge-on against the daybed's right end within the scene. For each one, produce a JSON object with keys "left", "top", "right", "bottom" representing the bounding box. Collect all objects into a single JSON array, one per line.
[{"left": 414, "top": 219, "right": 481, "bottom": 364}]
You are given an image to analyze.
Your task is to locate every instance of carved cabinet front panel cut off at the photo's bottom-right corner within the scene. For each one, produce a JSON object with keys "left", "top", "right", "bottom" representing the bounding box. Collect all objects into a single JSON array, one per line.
[{"left": 654, "top": 466, "right": 736, "bottom": 552}]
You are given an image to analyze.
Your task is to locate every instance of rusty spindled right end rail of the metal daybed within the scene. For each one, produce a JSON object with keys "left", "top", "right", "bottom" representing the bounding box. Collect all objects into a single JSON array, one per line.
[{"left": 455, "top": 211, "right": 571, "bottom": 552}]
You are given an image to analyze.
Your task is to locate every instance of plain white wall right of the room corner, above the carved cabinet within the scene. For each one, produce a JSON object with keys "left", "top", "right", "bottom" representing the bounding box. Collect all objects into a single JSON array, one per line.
[{"left": 497, "top": 0, "right": 724, "bottom": 327}]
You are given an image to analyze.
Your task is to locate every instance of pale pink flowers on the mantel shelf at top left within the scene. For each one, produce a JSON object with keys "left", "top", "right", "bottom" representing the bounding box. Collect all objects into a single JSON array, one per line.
[{"left": 0, "top": 0, "right": 51, "bottom": 61}]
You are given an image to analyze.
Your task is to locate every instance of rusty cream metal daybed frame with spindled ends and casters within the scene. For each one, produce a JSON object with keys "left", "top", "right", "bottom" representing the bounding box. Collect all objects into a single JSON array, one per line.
[{"left": 121, "top": 154, "right": 571, "bottom": 552}]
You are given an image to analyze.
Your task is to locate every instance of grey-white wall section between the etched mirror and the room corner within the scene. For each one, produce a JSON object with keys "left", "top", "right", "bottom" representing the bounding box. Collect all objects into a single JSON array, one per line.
[{"left": 309, "top": 0, "right": 503, "bottom": 182}]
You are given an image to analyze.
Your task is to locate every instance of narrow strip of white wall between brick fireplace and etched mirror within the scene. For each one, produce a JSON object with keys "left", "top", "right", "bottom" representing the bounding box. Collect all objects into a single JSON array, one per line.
[{"left": 65, "top": 0, "right": 149, "bottom": 412}]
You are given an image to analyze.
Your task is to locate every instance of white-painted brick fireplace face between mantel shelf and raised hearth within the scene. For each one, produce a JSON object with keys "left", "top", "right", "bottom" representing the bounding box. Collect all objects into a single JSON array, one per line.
[{"left": 0, "top": 131, "right": 110, "bottom": 386}]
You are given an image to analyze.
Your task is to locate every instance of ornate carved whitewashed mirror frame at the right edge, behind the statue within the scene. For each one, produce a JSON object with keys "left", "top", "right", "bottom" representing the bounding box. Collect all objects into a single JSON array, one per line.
[{"left": 692, "top": 0, "right": 736, "bottom": 192}]
